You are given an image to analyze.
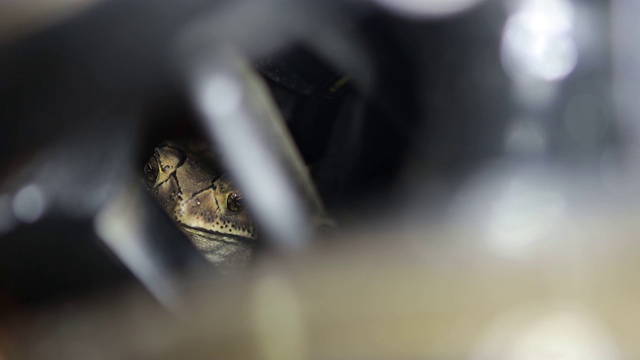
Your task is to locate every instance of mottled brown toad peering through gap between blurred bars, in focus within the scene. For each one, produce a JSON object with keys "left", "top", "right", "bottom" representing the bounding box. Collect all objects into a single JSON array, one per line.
[{"left": 145, "top": 141, "right": 256, "bottom": 269}]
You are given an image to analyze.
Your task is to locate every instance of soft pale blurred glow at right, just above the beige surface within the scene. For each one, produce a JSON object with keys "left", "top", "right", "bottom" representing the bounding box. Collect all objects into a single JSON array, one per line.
[{"left": 451, "top": 165, "right": 570, "bottom": 258}]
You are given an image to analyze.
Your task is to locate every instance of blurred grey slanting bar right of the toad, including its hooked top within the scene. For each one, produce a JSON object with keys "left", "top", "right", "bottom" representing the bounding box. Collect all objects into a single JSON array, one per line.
[{"left": 177, "top": 0, "right": 373, "bottom": 248}]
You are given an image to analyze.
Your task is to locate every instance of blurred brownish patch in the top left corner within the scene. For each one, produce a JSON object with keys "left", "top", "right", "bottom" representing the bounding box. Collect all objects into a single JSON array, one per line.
[{"left": 0, "top": 0, "right": 101, "bottom": 44}]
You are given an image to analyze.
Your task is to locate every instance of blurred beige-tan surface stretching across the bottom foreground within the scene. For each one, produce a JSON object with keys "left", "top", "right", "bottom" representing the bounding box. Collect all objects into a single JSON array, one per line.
[{"left": 7, "top": 208, "right": 640, "bottom": 359}]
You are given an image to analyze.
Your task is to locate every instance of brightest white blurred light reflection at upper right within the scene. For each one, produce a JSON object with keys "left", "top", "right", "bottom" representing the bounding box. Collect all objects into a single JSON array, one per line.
[{"left": 502, "top": 0, "right": 578, "bottom": 81}]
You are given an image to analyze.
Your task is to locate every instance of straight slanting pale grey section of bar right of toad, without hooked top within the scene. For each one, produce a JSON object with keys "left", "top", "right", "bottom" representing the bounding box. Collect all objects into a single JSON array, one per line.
[{"left": 191, "top": 57, "right": 323, "bottom": 249}]
